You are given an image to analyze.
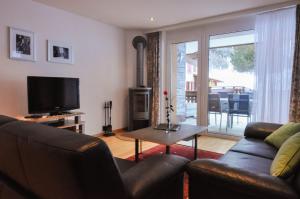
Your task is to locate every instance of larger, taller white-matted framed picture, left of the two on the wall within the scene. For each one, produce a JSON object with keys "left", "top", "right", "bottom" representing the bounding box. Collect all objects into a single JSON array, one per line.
[{"left": 9, "top": 27, "right": 36, "bottom": 61}]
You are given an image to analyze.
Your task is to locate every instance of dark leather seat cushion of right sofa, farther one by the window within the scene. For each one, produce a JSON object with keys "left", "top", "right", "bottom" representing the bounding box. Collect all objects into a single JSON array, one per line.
[{"left": 230, "top": 138, "right": 277, "bottom": 160}]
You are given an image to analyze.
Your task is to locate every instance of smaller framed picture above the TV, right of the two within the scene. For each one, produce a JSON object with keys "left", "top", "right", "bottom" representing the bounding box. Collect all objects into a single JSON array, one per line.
[{"left": 48, "top": 40, "right": 73, "bottom": 64}]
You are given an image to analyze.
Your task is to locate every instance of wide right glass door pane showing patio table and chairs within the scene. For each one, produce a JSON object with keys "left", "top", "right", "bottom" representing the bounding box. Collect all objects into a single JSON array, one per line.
[{"left": 207, "top": 31, "right": 255, "bottom": 136}]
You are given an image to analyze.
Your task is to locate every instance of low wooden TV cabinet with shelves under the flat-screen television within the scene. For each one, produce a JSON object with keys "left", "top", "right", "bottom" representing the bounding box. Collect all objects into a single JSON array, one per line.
[{"left": 16, "top": 112, "right": 85, "bottom": 134}]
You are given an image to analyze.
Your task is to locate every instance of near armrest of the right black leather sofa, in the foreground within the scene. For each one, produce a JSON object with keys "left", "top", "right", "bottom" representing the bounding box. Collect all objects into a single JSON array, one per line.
[{"left": 187, "top": 159, "right": 298, "bottom": 199}]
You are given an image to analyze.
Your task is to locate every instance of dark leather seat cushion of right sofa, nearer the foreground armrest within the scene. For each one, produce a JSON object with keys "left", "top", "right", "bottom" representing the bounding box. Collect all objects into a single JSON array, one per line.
[{"left": 220, "top": 151, "right": 272, "bottom": 175}]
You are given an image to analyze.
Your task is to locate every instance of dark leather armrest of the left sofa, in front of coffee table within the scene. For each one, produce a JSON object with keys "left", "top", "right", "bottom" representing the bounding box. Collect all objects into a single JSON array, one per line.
[{"left": 123, "top": 155, "right": 189, "bottom": 198}]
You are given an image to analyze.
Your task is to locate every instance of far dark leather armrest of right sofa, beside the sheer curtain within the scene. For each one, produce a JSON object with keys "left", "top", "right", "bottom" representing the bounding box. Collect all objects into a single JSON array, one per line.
[{"left": 244, "top": 122, "right": 282, "bottom": 140}]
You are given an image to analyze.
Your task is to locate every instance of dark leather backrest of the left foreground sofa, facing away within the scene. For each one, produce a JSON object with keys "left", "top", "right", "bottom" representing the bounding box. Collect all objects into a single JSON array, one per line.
[{"left": 0, "top": 118, "right": 126, "bottom": 199}]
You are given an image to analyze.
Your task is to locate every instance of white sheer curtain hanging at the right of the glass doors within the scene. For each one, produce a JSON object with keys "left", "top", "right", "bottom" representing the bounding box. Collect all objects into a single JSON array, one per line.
[{"left": 252, "top": 8, "right": 296, "bottom": 123}]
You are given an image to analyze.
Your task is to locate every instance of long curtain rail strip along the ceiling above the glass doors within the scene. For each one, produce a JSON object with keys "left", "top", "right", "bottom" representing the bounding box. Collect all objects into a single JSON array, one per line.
[{"left": 144, "top": 0, "right": 300, "bottom": 34}]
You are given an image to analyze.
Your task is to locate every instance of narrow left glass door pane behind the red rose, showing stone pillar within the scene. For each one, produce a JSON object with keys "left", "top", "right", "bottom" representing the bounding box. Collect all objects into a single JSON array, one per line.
[{"left": 171, "top": 41, "right": 198, "bottom": 125}]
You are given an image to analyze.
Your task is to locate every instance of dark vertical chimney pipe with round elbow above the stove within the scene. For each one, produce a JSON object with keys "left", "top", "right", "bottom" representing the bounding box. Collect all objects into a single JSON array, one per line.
[{"left": 132, "top": 36, "right": 147, "bottom": 87}]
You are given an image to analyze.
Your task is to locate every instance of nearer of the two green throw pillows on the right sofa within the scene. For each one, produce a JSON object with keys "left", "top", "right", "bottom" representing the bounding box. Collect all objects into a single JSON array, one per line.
[{"left": 270, "top": 132, "right": 300, "bottom": 178}]
